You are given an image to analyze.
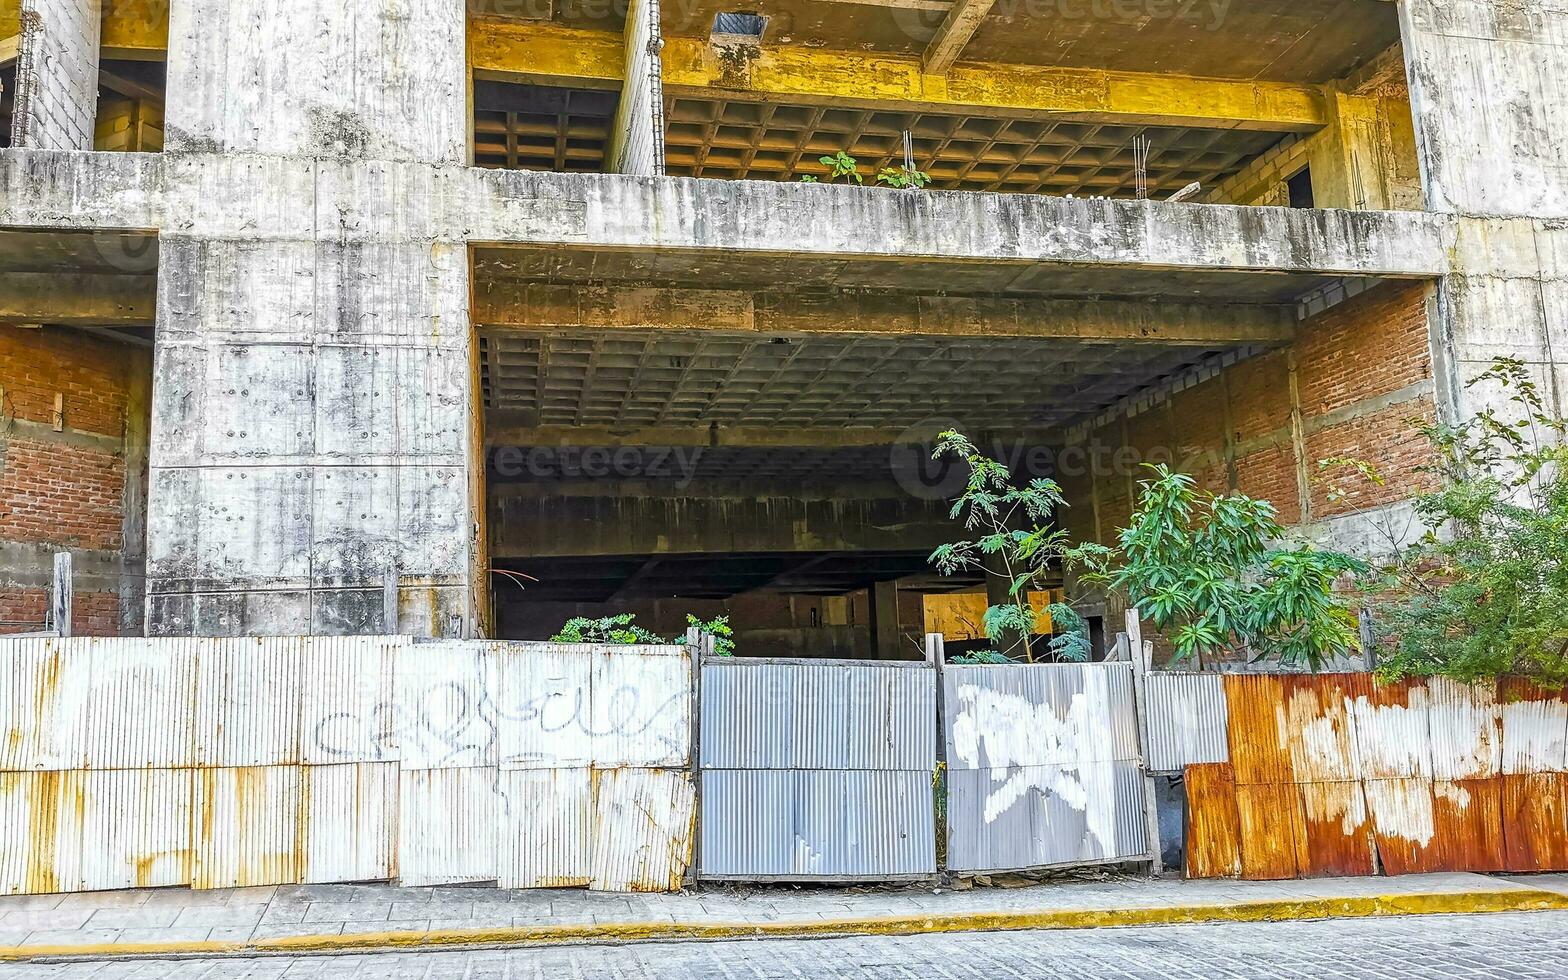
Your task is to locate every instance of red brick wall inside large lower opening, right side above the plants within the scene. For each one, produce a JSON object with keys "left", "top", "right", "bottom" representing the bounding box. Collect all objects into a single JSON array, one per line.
[{"left": 1069, "top": 282, "right": 1436, "bottom": 539}]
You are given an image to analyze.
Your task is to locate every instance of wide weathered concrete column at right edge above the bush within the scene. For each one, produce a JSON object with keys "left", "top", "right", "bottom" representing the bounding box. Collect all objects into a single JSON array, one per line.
[{"left": 1400, "top": 0, "right": 1568, "bottom": 416}]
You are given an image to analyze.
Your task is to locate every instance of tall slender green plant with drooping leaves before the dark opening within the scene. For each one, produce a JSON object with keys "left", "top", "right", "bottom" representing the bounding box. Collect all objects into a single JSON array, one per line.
[{"left": 930, "top": 430, "right": 1090, "bottom": 663}]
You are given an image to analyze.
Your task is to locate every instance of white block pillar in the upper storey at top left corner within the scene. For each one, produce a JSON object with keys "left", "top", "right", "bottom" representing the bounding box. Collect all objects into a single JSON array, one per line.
[{"left": 11, "top": 0, "right": 103, "bottom": 149}]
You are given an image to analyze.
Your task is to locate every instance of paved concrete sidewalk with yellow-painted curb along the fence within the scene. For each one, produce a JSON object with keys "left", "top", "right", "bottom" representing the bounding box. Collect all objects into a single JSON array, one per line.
[{"left": 0, "top": 873, "right": 1568, "bottom": 960}]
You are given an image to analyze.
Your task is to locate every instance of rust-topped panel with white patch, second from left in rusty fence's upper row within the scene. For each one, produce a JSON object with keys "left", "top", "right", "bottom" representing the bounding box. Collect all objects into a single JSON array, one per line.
[{"left": 1276, "top": 674, "right": 1370, "bottom": 782}]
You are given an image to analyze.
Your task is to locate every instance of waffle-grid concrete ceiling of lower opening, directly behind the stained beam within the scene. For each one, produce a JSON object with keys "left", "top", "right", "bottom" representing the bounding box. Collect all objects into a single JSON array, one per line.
[{"left": 480, "top": 329, "right": 1226, "bottom": 430}]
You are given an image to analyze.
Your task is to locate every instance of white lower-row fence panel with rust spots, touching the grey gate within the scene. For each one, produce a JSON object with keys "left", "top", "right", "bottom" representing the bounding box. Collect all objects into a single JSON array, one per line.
[{"left": 590, "top": 768, "right": 696, "bottom": 892}]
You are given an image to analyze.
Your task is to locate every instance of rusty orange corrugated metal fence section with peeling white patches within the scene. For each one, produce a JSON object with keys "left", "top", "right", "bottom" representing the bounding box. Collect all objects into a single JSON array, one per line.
[{"left": 1179, "top": 674, "right": 1568, "bottom": 878}]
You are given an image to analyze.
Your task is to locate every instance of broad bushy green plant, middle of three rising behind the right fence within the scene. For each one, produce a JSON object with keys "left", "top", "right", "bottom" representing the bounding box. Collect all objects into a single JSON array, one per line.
[{"left": 1065, "top": 466, "right": 1369, "bottom": 670}]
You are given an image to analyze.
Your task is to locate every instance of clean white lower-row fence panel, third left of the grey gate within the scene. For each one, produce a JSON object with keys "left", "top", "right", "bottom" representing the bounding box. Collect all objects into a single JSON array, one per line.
[{"left": 397, "top": 768, "right": 500, "bottom": 886}]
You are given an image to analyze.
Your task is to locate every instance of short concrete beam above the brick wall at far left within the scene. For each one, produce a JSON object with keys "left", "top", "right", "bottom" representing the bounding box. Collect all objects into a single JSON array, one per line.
[{"left": 0, "top": 273, "right": 158, "bottom": 326}]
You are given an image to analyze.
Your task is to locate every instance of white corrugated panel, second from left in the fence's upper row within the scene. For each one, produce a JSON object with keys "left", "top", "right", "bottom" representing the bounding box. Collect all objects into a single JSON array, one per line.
[{"left": 82, "top": 637, "right": 199, "bottom": 768}]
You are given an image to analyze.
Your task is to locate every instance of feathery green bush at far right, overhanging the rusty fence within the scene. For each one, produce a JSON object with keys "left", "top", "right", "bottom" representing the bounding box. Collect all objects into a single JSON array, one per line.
[{"left": 1367, "top": 358, "right": 1568, "bottom": 685}]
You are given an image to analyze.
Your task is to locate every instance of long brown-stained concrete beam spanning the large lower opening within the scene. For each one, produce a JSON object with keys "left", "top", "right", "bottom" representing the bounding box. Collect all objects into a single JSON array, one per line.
[{"left": 474, "top": 279, "right": 1295, "bottom": 347}]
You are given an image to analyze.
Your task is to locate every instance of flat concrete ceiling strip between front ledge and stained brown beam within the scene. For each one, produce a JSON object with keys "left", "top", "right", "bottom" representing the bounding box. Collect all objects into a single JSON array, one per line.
[{"left": 474, "top": 246, "right": 1354, "bottom": 304}]
